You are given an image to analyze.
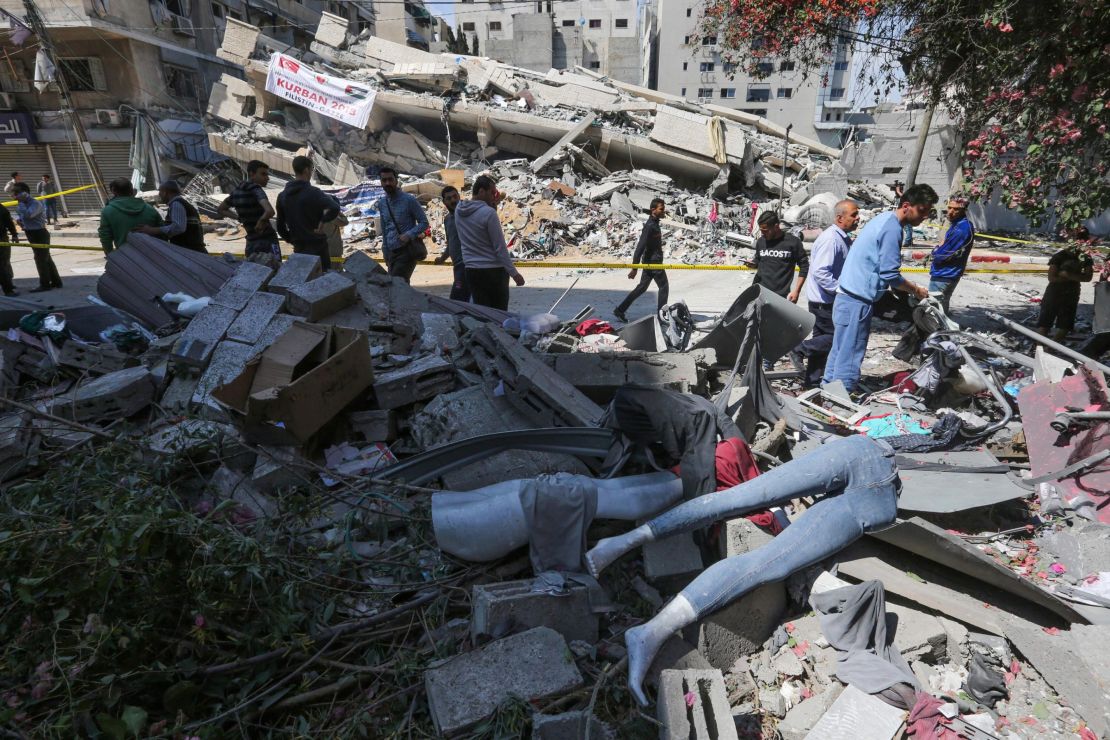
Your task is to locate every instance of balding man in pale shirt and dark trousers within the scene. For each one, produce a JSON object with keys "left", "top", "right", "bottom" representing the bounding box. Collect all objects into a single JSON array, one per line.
[{"left": 796, "top": 200, "right": 859, "bottom": 388}]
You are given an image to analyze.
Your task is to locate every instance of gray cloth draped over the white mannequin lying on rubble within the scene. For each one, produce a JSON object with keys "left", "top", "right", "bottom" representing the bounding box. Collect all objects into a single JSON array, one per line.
[{"left": 521, "top": 473, "right": 597, "bottom": 575}]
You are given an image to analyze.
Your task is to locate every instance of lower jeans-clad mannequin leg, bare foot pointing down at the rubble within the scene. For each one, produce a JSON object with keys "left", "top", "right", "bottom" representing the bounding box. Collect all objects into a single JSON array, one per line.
[{"left": 625, "top": 480, "right": 898, "bottom": 704}]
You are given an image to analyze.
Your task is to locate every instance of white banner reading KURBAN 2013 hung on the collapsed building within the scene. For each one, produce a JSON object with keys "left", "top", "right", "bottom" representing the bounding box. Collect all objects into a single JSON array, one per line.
[{"left": 266, "top": 53, "right": 377, "bottom": 129}]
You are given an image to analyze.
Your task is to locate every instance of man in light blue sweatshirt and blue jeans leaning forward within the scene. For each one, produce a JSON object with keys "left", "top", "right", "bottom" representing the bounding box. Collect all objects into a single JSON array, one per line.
[{"left": 823, "top": 185, "right": 938, "bottom": 392}]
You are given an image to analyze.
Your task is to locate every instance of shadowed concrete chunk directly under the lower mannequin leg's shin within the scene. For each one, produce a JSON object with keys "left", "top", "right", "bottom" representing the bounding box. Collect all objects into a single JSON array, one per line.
[{"left": 686, "top": 582, "right": 786, "bottom": 670}]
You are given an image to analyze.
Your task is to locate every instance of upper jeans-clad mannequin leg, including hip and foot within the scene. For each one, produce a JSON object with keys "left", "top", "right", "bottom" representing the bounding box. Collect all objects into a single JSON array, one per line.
[{"left": 586, "top": 435, "right": 898, "bottom": 578}]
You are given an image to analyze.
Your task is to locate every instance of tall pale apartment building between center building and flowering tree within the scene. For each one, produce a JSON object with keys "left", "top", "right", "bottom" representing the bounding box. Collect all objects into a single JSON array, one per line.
[{"left": 648, "top": 0, "right": 857, "bottom": 146}]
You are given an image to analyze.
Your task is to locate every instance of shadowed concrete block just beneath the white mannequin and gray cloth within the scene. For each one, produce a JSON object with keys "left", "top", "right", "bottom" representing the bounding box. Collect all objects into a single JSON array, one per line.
[{"left": 471, "top": 579, "right": 597, "bottom": 645}]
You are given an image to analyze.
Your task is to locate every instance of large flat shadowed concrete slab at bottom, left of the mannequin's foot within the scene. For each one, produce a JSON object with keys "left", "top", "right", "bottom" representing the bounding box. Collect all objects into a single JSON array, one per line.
[{"left": 424, "top": 627, "right": 583, "bottom": 736}]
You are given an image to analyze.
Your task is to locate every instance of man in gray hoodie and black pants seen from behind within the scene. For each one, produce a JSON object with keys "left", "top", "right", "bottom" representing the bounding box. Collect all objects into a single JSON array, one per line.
[{"left": 455, "top": 175, "right": 524, "bottom": 311}]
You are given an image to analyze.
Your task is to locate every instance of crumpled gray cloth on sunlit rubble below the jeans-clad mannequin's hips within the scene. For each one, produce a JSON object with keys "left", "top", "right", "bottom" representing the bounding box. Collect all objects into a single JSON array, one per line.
[{"left": 809, "top": 580, "right": 921, "bottom": 709}]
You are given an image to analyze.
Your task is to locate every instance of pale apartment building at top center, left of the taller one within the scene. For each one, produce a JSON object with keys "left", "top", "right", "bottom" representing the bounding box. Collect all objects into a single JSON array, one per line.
[{"left": 454, "top": 0, "right": 644, "bottom": 84}]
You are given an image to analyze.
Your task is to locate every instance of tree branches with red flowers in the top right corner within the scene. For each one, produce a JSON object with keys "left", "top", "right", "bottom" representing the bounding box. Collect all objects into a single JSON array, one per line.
[{"left": 700, "top": 0, "right": 1110, "bottom": 226}]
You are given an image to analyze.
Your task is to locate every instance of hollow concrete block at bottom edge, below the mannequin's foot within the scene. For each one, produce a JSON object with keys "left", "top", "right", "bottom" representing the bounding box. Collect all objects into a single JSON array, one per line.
[{"left": 656, "top": 670, "right": 738, "bottom": 740}]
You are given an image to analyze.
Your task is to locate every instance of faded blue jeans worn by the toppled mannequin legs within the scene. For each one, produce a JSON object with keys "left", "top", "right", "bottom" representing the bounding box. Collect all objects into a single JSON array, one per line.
[{"left": 648, "top": 437, "right": 901, "bottom": 618}]
